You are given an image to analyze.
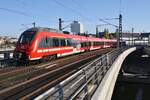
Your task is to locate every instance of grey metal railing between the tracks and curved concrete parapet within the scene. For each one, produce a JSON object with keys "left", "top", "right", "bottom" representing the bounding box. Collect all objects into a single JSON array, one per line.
[{"left": 35, "top": 49, "right": 124, "bottom": 100}]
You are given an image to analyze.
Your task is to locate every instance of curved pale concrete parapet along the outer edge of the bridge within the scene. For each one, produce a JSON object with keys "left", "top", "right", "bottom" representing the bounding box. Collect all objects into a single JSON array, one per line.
[{"left": 92, "top": 47, "right": 136, "bottom": 100}]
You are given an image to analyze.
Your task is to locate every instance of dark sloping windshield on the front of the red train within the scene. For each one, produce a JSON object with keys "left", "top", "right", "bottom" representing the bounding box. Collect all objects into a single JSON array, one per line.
[{"left": 19, "top": 31, "right": 36, "bottom": 43}]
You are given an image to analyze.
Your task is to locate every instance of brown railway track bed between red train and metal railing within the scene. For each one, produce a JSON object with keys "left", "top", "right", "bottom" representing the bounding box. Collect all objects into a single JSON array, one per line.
[{"left": 0, "top": 48, "right": 115, "bottom": 100}]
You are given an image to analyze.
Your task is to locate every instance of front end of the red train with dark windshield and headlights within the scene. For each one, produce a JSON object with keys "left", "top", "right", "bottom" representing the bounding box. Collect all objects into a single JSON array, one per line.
[{"left": 13, "top": 30, "right": 36, "bottom": 61}]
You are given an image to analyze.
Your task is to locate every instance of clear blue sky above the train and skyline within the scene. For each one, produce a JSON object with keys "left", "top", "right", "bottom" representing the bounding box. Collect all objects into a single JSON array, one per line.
[{"left": 0, "top": 0, "right": 150, "bottom": 36}]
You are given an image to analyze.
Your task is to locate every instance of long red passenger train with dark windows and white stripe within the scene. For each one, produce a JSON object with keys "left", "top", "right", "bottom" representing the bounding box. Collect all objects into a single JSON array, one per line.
[{"left": 14, "top": 28, "right": 117, "bottom": 60}]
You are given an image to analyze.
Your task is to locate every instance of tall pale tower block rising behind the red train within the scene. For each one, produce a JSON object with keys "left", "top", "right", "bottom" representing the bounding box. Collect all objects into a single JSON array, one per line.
[{"left": 71, "top": 21, "right": 84, "bottom": 34}]
